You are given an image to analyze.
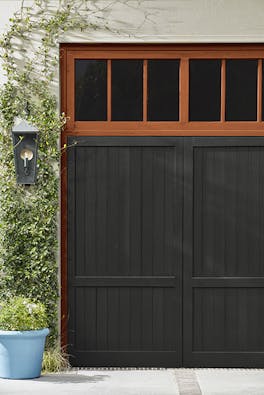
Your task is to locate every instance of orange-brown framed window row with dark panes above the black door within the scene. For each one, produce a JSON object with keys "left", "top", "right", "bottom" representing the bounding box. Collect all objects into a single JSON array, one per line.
[{"left": 61, "top": 44, "right": 264, "bottom": 135}]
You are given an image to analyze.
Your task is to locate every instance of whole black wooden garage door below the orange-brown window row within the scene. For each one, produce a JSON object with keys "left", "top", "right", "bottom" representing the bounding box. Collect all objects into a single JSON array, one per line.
[{"left": 68, "top": 137, "right": 264, "bottom": 367}]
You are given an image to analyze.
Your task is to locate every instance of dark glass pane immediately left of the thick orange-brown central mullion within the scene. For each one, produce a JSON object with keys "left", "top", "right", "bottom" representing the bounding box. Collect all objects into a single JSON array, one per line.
[{"left": 148, "top": 59, "right": 179, "bottom": 121}]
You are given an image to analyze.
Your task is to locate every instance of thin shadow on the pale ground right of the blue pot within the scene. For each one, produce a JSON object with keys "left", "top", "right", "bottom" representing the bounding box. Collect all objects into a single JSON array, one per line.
[{"left": 35, "top": 373, "right": 110, "bottom": 384}]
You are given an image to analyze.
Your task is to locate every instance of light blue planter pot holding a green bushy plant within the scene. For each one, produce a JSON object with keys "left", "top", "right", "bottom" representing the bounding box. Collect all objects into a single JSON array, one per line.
[{"left": 0, "top": 328, "right": 49, "bottom": 379}]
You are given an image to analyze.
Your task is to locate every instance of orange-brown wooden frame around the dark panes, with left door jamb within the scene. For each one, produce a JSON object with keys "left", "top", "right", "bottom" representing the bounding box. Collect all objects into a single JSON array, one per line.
[{"left": 60, "top": 44, "right": 264, "bottom": 346}]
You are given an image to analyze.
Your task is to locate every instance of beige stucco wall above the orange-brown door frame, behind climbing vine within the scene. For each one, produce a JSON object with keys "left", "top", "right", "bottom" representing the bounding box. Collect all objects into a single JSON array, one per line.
[{"left": 0, "top": 0, "right": 264, "bottom": 86}]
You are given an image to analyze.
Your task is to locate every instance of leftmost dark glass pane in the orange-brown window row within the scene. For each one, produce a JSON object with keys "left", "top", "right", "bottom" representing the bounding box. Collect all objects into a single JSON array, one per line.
[{"left": 75, "top": 59, "right": 107, "bottom": 121}]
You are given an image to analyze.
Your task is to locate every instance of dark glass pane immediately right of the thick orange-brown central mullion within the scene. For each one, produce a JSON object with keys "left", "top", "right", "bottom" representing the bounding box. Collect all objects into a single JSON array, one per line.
[{"left": 189, "top": 59, "right": 221, "bottom": 121}]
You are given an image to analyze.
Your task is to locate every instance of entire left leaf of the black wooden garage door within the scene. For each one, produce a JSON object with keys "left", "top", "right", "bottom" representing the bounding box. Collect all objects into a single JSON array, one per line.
[{"left": 68, "top": 138, "right": 183, "bottom": 366}]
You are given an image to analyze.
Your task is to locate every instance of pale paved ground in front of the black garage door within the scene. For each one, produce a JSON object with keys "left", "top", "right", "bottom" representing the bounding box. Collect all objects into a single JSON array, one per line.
[{"left": 0, "top": 369, "right": 264, "bottom": 395}]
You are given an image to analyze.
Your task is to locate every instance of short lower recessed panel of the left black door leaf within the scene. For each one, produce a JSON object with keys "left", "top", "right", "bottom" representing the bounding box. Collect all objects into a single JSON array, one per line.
[{"left": 74, "top": 286, "right": 178, "bottom": 352}]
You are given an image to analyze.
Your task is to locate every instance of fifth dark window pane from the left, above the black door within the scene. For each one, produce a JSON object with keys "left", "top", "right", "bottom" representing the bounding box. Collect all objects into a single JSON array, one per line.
[{"left": 226, "top": 59, "right": 258, "bottom": 121}]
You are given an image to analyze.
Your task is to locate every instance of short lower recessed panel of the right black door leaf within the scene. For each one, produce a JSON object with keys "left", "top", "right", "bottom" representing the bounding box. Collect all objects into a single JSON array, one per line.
[{"left": 193, "top": 287, "right": 264, "bottom": 352}]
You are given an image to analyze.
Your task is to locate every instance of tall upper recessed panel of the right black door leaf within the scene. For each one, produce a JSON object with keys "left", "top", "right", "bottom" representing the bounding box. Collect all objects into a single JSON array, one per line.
[{"left": 193, "top": 146, "right": 264, "bottom": 277}]
